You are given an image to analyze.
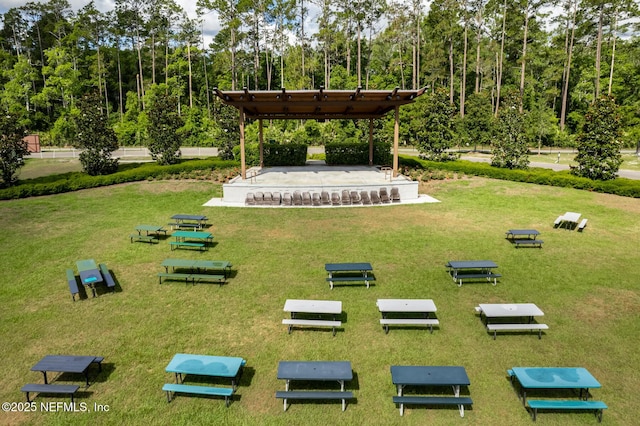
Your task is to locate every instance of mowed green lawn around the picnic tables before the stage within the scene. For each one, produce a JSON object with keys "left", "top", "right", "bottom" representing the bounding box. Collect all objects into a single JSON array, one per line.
[{"left": 0, "top": 178, "right": 640, "bottom": 425}]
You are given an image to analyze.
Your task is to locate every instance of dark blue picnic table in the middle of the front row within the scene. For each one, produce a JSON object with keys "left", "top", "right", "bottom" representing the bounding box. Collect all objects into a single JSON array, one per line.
[{"left": 276, "top": 361, "right": 353, "bottom": 411}]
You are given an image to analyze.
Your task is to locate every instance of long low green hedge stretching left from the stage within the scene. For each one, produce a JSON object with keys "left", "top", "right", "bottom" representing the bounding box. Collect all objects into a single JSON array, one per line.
[{"left": 0, "top": 159, "right": 238, "bottom": 200}]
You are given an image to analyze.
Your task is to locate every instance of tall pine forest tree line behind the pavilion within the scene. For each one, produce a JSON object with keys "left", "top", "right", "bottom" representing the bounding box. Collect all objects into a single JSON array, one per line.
[{"left": 0, "top": 0, "right": 640, "bottom": 158}]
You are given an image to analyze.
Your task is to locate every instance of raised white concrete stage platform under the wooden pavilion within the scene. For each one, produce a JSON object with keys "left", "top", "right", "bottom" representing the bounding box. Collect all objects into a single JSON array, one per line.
[{"left": 204, "top": 161, "right": 438, "bottom": 208}]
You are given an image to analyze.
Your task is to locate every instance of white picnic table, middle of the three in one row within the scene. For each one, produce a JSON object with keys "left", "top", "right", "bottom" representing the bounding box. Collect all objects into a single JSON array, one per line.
[{"left": 376, "top": 299, "right": 439, "bottom": 333}]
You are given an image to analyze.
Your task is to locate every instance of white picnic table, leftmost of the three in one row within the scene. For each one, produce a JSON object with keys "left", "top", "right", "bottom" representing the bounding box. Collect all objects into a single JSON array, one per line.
[{"left": 282, "top": 299, "right": 342, "bottom": 336}]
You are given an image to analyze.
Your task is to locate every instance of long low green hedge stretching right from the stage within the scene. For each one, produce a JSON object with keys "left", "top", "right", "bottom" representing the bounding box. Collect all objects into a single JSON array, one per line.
[{"left": 400, "top": 156, "right": 640, "bottom": 198}]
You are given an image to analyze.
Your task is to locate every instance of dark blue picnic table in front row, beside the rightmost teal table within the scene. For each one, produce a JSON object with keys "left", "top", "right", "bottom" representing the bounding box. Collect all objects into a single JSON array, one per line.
[{"left": 391, "top": 365, "right": 472, "bottom": 417}]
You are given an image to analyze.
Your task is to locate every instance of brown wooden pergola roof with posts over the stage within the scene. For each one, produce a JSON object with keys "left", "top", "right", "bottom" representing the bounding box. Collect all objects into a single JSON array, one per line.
[{"left": 214, "top": 87, "right": 427, "bottom": 179}]
